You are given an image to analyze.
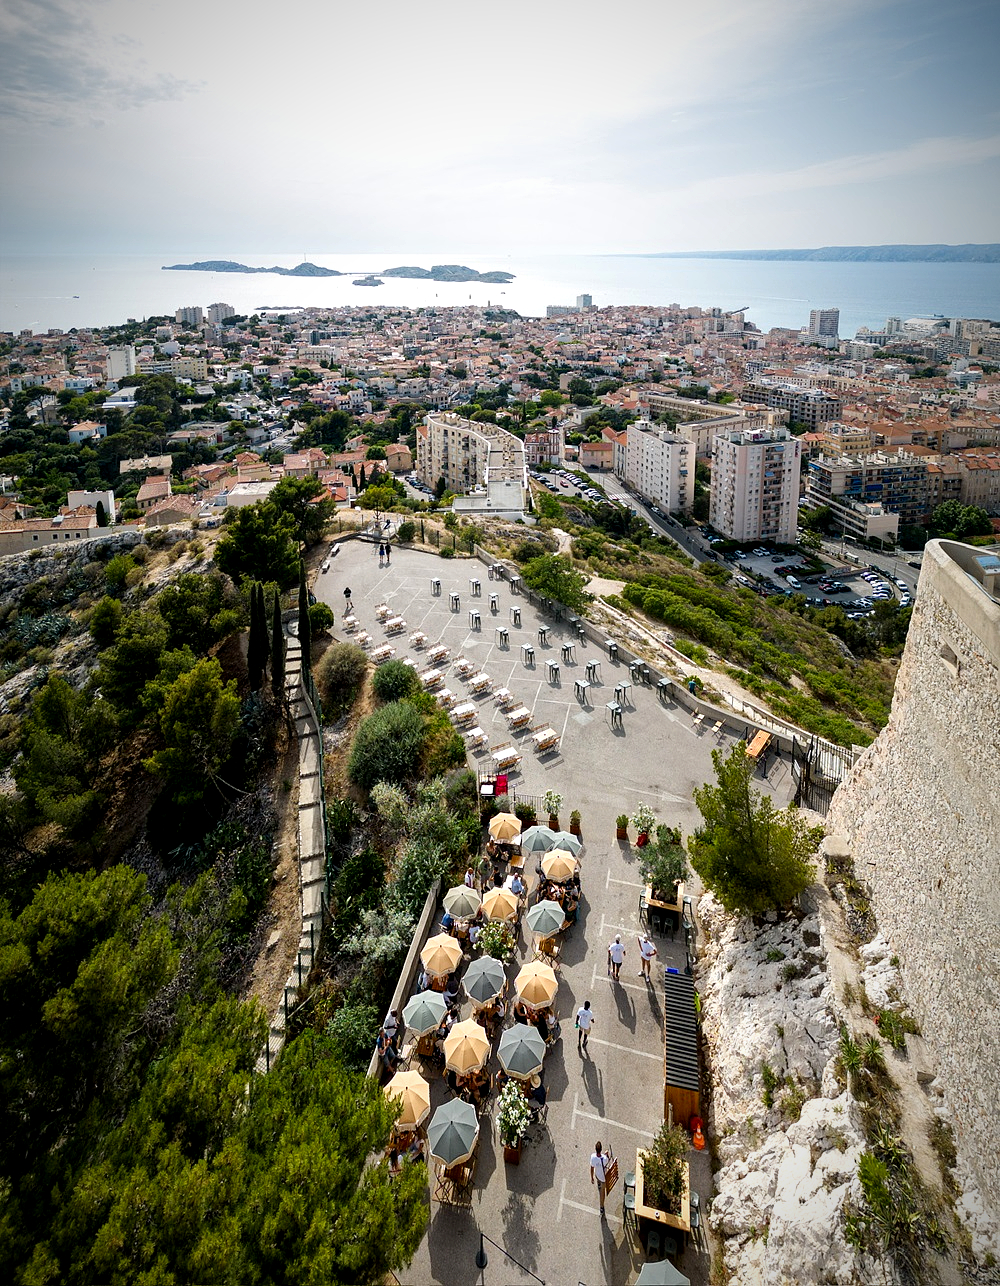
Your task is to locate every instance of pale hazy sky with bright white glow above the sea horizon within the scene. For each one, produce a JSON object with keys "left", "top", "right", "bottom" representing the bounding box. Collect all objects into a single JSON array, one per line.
[{"left": 0, "top": 0, "right": 1000, "bottom": 262}]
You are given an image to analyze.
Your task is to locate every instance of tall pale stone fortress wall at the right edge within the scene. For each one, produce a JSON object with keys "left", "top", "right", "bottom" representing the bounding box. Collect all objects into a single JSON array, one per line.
[{"left": 828, "top": 541, "right": 1000, "bottom": 1211}]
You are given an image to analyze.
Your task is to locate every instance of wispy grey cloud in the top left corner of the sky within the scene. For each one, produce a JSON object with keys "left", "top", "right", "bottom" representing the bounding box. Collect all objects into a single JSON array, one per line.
[{"left": 0, "top": 0, "right": 197, "bottom": 126}]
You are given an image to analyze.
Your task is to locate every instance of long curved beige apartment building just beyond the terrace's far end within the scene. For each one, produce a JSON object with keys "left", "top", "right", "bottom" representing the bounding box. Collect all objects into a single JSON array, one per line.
[{"left": 416, "top": 412, "right": 528, "bottom": 513}]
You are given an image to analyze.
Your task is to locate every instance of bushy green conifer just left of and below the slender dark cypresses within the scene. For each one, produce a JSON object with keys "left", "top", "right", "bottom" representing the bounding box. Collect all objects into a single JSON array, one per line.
[{"left": 143, "top": 658, "right": 239, "bottom": 805}]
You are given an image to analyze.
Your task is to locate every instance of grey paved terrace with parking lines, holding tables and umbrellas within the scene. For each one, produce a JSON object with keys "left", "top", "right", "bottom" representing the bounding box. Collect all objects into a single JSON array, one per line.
[{"left": 314, "top": 540, "right": 792, "bottom": 1286}]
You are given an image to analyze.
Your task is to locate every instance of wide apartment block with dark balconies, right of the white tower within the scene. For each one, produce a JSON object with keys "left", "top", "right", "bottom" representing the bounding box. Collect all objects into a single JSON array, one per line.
[{"left": 805, "top": 451, "right": 929, "bottom": 525}]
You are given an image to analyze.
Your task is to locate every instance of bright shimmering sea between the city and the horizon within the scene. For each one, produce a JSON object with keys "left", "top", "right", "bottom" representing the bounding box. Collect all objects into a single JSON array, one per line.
[{"left": 0, "top": 249, "right": 1000, "bottom": 337}]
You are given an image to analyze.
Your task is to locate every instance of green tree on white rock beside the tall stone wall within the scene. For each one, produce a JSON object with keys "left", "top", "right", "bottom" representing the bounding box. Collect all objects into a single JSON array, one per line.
[{"left": 689, "top": 741, "right": 816, "bottom": 916}]
